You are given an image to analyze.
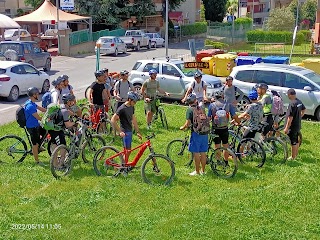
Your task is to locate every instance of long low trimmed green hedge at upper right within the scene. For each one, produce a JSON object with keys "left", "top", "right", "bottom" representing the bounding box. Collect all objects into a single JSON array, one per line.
[{"left": 247, "top": 30, "right": 305, "bottom": 45}]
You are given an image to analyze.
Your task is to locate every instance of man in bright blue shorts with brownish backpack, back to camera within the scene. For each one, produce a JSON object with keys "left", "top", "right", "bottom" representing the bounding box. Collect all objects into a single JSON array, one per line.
[{"left": 180, "top": 93, "right": 208, "bottom": 176}]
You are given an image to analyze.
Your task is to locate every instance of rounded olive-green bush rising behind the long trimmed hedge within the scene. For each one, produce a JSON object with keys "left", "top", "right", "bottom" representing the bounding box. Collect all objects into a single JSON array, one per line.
[{"left": 267, "top": 8, "right": 295, "bottom": 31}]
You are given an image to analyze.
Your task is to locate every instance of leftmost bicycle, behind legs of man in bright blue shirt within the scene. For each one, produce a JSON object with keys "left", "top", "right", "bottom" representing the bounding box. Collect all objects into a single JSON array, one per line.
[{"left": 0, "top": 128, "right": 51, "bottom": 163}]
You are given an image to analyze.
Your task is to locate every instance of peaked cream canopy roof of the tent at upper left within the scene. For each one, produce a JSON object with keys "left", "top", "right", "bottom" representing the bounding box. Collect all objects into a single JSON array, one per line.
[{"left": 13, "top": 0, "right": 90, "bottom": 22}]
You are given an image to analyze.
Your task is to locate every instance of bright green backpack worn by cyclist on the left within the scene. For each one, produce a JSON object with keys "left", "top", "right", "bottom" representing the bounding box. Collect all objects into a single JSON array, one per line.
[{"left": 41, "top": 103, "right": 62, "bottom": 131}]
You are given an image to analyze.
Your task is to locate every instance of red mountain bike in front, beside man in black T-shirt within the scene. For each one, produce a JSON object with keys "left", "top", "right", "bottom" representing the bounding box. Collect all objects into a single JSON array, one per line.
[{"left": 93, "top": 134, "right": 175, "bottom": 185}]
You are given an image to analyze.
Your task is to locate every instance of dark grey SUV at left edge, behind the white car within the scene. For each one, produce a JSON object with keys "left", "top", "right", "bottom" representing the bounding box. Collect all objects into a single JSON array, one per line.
[{"left": 0, "top": 41, "right": 51, "bottom": 72}]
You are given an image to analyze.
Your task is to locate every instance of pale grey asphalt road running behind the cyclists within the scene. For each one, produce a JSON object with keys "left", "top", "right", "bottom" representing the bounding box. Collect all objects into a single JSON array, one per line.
[{"left": 0, "top": 40, "right": 204, "bottom": 125}]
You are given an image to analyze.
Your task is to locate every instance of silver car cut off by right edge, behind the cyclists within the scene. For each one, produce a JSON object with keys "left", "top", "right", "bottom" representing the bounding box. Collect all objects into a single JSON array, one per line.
[{"left": 230, "top": 63, "right": 320, "bottom": 121}]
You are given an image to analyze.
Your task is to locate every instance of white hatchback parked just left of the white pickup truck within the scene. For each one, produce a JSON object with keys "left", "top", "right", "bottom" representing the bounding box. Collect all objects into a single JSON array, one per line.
[{"left": 95, "top": 36, "right": 127, "bottom": 56}]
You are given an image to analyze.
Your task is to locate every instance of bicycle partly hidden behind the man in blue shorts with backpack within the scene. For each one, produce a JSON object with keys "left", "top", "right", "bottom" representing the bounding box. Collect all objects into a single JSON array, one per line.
[{"left": 166, "top": 130, "right": 238, "bottom": 178}]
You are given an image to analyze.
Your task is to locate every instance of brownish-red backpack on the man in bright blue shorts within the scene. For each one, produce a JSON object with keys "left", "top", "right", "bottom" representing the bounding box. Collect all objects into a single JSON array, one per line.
[{"left": 192, "top": 106, "right": 210, "bottom": 135}]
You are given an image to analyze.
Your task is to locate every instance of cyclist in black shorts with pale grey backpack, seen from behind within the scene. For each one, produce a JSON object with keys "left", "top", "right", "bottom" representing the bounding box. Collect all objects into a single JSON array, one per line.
[{"left": 208, "top": 90, "right": 239, "bottom": 165}]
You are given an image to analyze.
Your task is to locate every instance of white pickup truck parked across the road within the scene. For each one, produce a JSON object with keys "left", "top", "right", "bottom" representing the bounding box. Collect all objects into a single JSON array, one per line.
[{"left": 120, "top": 30, "right": 151, "bottom": 51}]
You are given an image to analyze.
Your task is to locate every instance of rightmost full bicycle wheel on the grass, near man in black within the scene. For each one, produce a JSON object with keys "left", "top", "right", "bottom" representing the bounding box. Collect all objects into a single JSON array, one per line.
[{"left": 263, "top": 137, "right": 288, "bottom": 163}]
